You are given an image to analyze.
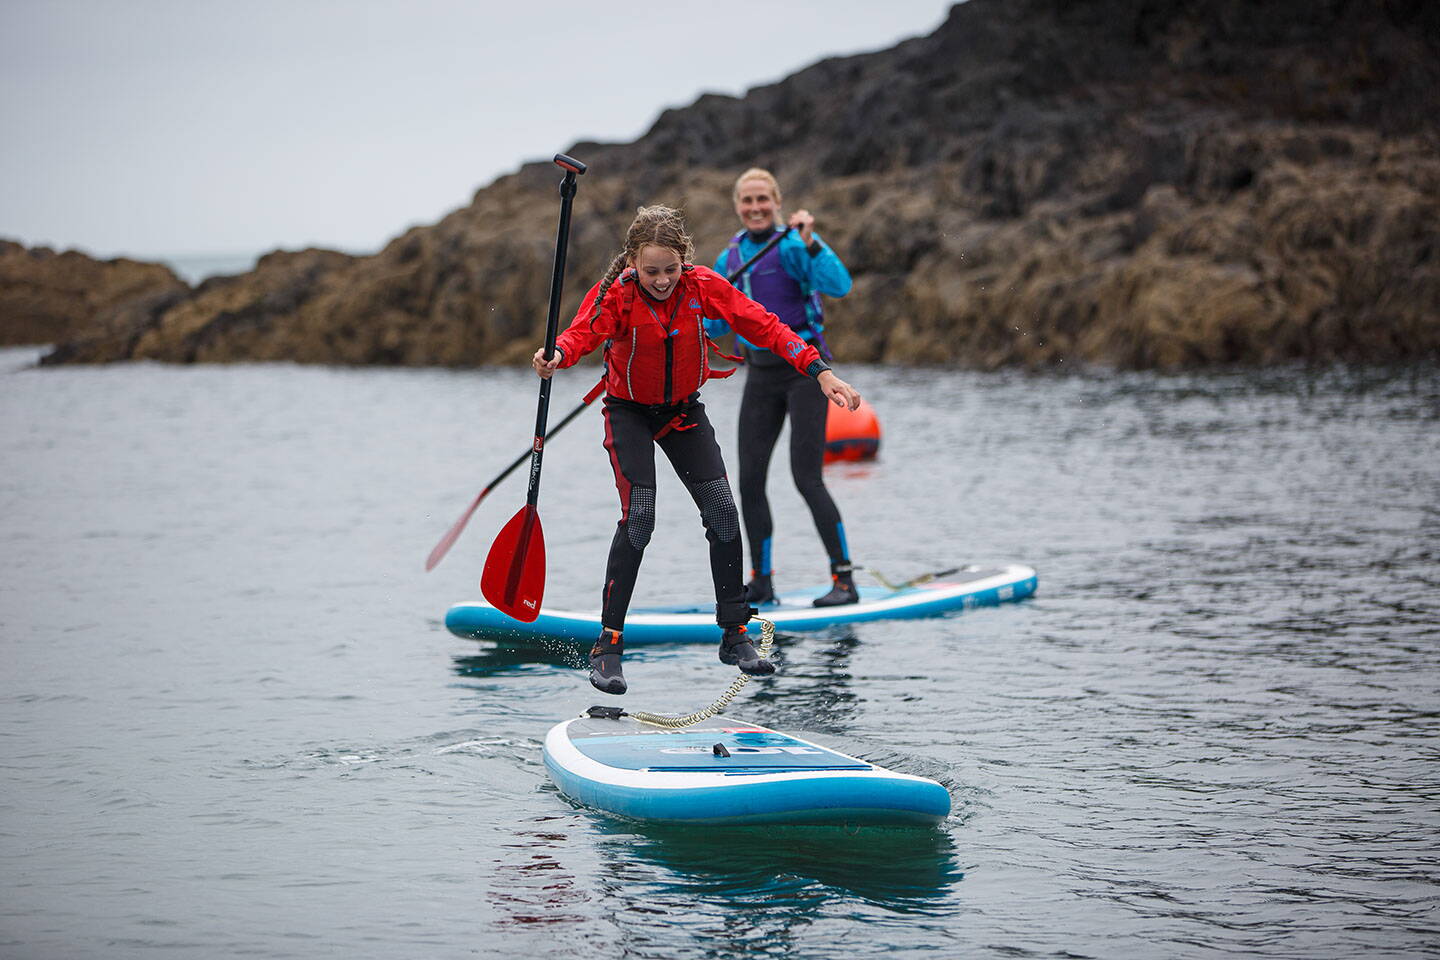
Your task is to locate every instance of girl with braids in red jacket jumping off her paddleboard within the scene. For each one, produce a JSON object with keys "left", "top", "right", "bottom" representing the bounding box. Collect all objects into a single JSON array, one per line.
[{"left": 531, "top": 206, "right": 860, "bottom": 694}]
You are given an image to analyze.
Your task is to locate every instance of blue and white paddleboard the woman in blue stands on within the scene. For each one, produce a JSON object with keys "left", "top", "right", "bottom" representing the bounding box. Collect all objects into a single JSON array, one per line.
[{"left": 445, "top": 564, "right": 1037, "bottom": 646}]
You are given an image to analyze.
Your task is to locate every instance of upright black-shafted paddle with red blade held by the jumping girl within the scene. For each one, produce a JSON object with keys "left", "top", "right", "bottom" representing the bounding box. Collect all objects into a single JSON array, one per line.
[{"left": 480, "top": 154, "right": 585, "bottom": 623}]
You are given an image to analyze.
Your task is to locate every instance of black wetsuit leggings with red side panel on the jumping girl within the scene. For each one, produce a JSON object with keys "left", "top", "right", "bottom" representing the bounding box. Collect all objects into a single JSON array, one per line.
[{"left": 600, "top": 394, "right": 749, "bottom": 632}]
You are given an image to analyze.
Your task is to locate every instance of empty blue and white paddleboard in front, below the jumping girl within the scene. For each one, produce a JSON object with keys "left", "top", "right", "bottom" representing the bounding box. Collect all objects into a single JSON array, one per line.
[{"left": 544, "top": 708, "right": 950, "bottom": 826}]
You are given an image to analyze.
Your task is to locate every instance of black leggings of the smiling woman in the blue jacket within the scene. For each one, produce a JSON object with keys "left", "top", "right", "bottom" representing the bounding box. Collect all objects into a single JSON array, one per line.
[{"left": 740, "top": 360, "right": 850, "bottom": 574}]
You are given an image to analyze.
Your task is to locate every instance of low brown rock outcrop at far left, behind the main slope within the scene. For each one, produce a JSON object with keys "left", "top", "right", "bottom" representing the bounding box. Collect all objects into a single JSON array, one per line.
[{"left": 0, "top": 240, "right": 186, "bottom": 347}]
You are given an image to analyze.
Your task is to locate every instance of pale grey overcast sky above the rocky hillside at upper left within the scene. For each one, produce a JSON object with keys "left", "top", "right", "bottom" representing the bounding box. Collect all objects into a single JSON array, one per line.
[{"left": 0, "top": 0, "right": 950, "bottom": 258}]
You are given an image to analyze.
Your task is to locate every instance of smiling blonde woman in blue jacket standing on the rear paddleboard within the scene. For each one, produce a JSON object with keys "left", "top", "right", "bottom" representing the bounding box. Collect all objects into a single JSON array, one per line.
[{"left": 706, "top": 167, "right": 860, "bottom": 606}]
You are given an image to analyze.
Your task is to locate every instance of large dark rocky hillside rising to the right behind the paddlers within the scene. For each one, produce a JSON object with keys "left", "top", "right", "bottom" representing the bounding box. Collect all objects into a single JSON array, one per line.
[{"left": 33, "top": 0, "right": 1440, "bottom": 368}]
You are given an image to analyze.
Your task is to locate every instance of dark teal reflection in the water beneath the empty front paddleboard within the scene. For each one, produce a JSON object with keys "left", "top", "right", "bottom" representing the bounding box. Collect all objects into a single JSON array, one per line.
[{"left": 595, "top": 818, "right": 963, "bottom": 960}]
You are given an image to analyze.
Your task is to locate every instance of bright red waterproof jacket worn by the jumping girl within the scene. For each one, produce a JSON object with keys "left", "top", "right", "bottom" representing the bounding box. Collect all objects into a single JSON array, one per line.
[{"left": 554, "top": 265, "right": 819, "bottom": 404}]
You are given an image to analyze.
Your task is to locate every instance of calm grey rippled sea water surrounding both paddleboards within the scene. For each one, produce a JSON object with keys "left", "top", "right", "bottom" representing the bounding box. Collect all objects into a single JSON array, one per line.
[{"left": 0, "top": 350, "right": 1440, "bottom": 960}]
